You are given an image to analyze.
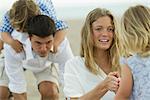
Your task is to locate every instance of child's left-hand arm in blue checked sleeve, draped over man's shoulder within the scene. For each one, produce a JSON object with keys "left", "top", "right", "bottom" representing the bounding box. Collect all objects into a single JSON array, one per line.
[{"left": 0, "top": 13, "right": 23, "bottom": 53}]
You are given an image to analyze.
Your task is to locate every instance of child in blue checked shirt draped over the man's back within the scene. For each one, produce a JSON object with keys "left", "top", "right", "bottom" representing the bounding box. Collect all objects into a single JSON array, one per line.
[{"left": 0, "top": 0, "right": 73, "bottom": 82}]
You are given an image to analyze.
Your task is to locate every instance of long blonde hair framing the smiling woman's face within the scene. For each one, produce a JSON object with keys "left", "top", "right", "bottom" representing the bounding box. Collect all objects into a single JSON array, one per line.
[{"left": 80, "top": 8, "right": 119, "bottom": 74}]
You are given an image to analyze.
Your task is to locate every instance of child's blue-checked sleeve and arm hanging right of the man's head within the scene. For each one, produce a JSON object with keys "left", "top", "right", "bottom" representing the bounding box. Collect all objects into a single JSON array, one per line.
[{"left": 37, "top": 0, "right": 68, "bottom": 53}]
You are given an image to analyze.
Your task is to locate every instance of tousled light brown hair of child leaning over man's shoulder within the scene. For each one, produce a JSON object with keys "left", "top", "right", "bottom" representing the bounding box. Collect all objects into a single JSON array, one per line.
[{"left": 9, "top": 0, "right": 40, "bottom": 32}]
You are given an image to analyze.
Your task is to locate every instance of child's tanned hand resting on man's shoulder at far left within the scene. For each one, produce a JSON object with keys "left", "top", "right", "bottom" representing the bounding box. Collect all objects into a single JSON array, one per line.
[{"left": 10, "top": 40, "right": 23, "bottom": 53}]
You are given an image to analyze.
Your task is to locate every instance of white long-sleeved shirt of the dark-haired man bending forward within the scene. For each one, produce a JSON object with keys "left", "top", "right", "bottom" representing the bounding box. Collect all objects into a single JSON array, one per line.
[{"left": 4, "top": 31, "right": 72, "bottom": 93}]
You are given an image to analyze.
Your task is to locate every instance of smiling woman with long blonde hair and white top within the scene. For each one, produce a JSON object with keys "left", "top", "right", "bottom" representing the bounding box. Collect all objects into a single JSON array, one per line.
[{"left": 64, "top": 8, "right": 120, "bottom": 100}]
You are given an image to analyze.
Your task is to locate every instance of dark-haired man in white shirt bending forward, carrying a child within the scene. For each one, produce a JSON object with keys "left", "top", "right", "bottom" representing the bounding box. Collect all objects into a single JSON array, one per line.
[{"left": 4, "top": 15, "right": 68, "bottom": 100}]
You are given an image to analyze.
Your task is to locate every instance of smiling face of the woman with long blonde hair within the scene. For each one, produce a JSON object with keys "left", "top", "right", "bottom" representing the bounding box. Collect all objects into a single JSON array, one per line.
[{"left": 92, "top": 16, "right": 114, "bottom": 50}]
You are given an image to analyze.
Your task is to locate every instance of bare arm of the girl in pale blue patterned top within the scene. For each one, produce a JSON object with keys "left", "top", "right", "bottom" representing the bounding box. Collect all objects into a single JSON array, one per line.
[{"left": 115, "top": 65, "right": 133, "bottom": 100}]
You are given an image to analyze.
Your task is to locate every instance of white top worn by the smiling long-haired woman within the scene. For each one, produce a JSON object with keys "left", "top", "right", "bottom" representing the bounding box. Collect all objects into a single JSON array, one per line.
[{"left": 64, "top": 57, "right": 115, "bottom": 100}]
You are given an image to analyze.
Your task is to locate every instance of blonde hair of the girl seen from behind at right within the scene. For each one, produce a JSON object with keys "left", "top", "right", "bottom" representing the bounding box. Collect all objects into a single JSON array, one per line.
[{"left": 120, "top": 5, "right": 150, "bottom": 56}]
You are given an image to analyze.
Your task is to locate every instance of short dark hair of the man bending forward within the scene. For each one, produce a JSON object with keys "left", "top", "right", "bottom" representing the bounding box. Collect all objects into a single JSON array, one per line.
[{"left": 27, "top": 15, "right": 56, "bottom": 38}]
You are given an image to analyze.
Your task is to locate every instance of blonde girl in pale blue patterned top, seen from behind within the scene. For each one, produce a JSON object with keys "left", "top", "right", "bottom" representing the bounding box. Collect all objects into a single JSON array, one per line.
[{"left": 115, "top": 5, "right": 150, "bottom": 100}]
